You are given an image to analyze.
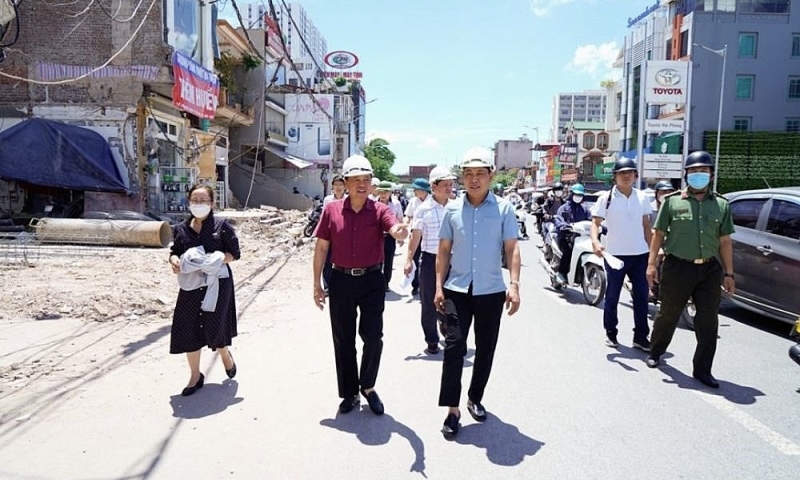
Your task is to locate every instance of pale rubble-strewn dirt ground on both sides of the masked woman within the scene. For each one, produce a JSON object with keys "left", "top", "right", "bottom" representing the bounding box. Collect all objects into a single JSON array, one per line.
[{"left": 0, "top": 211, "right": 313, "bottom": 408}]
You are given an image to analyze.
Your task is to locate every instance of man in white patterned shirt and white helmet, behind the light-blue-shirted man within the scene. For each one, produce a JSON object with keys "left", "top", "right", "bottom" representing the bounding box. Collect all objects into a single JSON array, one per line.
[{"left": 403, "top": 167, "right": 456, "bottom": 355}]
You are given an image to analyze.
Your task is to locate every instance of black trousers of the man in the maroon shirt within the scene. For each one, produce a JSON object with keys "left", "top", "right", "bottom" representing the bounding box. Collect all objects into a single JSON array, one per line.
[{"left": 328, "top": 270, "right": 386, "bottom": 398}]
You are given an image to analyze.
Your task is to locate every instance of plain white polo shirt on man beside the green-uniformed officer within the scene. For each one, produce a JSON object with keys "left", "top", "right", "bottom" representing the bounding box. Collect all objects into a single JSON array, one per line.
[{"left": 592, "top": 187, "right": 653, "bottom": 255}]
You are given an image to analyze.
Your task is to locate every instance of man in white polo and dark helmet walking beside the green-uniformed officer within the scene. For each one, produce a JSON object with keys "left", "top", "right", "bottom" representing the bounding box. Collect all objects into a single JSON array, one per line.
[{"left": 591, "top": 157, "right": 653, "bottom": 352}]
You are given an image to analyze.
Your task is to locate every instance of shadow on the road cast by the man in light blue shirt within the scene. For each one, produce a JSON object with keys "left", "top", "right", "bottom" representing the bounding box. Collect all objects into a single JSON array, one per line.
[{"left": 454, "top": 412, "right": 544, "bottom": 467}]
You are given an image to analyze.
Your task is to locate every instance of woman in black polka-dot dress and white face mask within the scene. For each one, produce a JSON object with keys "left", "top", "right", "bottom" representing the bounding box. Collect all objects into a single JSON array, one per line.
[{"left": 169, "top": 185, "right": 240, "bottom": 396}]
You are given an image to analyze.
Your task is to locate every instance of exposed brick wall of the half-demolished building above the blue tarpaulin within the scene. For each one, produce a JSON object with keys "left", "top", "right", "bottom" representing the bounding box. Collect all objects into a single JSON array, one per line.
[{"left": 0, "top": 0, "right": 169, "bottom": 108}]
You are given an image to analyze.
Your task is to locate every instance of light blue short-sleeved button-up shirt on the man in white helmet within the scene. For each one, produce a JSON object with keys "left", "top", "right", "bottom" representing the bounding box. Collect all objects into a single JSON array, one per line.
[{"left": 439, "top": 192, "right": 519, "bottom": 295}]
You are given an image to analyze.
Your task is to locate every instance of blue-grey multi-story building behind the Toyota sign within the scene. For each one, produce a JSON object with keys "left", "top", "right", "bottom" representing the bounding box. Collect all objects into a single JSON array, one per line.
[{"left": 621, "top": 0, "right": 800, "bottom": 186}]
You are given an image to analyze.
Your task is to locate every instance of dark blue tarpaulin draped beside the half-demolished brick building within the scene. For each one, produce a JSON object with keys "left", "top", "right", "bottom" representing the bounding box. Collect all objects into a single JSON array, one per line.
[{"left": 0, "top": 118, "right": 127, "bottom": 193}]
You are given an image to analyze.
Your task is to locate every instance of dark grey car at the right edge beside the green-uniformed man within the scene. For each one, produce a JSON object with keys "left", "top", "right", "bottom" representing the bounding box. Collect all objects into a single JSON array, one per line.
[{"left": 725, "top": 187, "right": 800, "bottom": 323}]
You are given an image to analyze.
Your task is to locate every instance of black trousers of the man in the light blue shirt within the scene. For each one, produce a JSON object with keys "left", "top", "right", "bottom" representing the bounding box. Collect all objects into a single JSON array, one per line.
[{"left": 439, "top": 287, "right": 506, "bottom": 407}]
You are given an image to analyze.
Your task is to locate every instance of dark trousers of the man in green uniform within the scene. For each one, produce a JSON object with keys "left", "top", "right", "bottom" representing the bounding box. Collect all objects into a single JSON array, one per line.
[{"left": 650, "top": 255, "right": 723, "bottom": 375}]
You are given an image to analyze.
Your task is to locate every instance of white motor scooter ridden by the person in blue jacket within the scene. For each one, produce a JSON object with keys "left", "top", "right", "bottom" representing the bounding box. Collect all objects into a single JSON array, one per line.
[{"left": 539, "top": 220, "right": 608, "bottom": 306}]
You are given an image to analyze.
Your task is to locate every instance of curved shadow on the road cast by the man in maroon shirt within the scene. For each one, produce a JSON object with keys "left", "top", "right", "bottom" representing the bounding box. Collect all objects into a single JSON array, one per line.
[{"left": 319, "top": 407, "right": 427, "bottom": 478}]
